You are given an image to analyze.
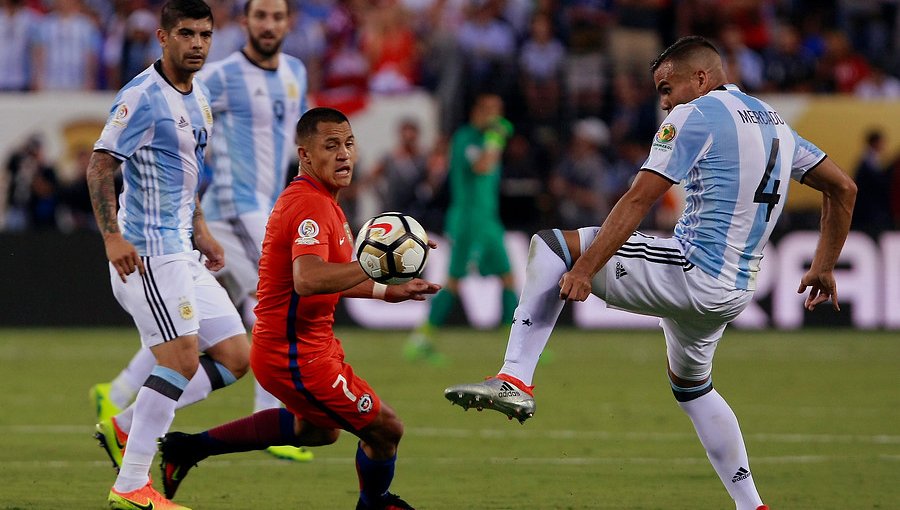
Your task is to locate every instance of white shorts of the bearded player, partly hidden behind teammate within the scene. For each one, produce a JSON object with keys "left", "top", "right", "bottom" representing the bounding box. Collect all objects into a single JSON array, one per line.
[{"left": 206, "top": 212, "right": 269, "bottom": 304}]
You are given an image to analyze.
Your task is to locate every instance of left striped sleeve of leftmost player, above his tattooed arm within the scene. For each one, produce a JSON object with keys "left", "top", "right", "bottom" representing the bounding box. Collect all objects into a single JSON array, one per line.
[{"left": 94, "top": 89, "right": 154, "bottom": 161}]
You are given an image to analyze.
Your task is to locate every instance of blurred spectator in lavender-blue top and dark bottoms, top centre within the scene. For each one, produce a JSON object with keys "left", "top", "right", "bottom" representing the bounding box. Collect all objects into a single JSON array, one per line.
[{"left": 457, "top": 0, "right": 517, "bottom": 104}]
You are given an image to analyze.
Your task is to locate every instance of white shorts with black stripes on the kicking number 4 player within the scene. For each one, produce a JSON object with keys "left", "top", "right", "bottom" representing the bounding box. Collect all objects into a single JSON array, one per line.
[{"left": 579, "top": 227, "right": 753, "bottom": 381}]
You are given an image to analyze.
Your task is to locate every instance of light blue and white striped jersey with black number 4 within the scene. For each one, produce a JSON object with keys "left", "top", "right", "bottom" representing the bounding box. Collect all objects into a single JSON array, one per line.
[{"left": 642, "top": 84, "right": 825, "bottom": 290}]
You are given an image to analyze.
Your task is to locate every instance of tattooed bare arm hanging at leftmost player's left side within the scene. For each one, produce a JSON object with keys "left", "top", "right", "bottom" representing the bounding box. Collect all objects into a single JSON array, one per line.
[{"left": 87, "top": 151, "right": 144, "bottom": 282}]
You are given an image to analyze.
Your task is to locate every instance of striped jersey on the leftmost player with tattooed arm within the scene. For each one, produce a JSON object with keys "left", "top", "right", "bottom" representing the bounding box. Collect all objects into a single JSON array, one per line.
[{"left": 94, "top": 61, "right": 213, "bottom": 256}]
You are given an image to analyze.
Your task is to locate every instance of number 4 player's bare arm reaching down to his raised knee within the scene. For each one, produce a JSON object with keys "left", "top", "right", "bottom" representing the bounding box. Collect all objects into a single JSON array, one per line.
[{"left": 559, "top": 171, "right": 672, "bottom": 301}]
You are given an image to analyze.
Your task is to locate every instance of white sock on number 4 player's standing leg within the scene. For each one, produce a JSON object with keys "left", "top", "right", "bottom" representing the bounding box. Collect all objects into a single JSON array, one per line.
[{"left": 678, "top": 389, "right": 762, "bottom": 510}]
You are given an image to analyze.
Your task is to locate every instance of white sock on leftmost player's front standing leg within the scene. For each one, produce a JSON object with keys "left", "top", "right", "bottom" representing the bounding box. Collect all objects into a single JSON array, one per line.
[{"left": 113, "top": 386, "right": 175, "bottom": 492}]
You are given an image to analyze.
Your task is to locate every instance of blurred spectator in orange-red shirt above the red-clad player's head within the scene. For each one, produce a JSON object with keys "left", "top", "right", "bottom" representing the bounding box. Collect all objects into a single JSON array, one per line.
[{"left": 362, "top": 0, "right": 419, "bottom": 94}]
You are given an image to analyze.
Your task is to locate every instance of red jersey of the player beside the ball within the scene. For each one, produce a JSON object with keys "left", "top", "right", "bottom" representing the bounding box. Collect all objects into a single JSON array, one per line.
[{"left": 253, "top": 176, "right": 353, "bottom": 361}]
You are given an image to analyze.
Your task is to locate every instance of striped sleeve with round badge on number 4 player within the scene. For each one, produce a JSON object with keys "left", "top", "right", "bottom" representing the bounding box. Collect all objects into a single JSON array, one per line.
[{"left": 641, "top": 104, "right": 712, "bottom": 183}]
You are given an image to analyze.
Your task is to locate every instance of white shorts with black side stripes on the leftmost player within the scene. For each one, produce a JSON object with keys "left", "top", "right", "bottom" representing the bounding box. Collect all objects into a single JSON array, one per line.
[{"left": 109, "top": 251, "right": 246, "bottom": 351}]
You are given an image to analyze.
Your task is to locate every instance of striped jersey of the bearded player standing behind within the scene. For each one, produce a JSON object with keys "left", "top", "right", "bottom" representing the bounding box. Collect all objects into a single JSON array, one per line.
[{"left": 199, "top": 51, "right": 307, "bottom": 220}]
